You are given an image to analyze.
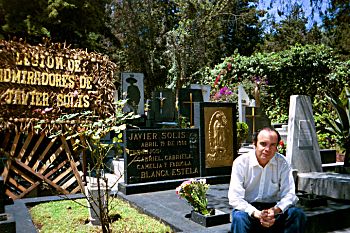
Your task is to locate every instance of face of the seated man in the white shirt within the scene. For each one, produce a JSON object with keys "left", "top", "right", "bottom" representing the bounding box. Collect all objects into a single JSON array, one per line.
[{"left": 255, "top": 130, "right": 278, "bottom": 167}]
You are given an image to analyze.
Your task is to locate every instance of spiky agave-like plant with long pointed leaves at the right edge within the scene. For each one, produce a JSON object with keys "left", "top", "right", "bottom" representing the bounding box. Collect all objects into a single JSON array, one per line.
[{"left": 325, "top": 86, "right": 350, "bottom": 170}]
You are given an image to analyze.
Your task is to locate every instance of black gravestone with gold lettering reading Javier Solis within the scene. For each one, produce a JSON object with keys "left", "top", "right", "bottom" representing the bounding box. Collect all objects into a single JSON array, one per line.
[{"left": 119, "top": 128, "right": 200, "bottom": 194}]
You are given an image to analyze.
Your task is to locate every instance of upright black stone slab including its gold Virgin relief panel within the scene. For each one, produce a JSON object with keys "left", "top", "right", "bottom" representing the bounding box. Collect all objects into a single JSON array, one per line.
[{"left": 194, "top": 102, "right": 238, "bottom": 177}]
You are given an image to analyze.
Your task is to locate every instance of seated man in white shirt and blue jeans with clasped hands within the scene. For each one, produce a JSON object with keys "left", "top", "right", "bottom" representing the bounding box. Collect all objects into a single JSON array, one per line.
[{"left": 228, "top": 127, "right": 306, "bottom": 233}]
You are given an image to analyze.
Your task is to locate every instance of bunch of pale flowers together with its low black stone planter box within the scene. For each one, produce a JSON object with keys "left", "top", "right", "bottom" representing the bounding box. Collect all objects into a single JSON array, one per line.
[{"left": 176, "top": 179, "right": 230, "bottom": 227}]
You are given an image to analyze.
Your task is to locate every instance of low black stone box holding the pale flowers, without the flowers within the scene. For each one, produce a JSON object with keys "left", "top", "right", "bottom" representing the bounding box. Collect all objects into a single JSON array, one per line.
[{"left": 191, "top": 209, "right": 230, "bottom": 227}]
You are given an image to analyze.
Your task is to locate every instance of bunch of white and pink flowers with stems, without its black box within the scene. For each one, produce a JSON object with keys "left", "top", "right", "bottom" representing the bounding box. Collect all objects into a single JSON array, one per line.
[{"left": 176, "top": 179, "right": 210, "bottom": 215}]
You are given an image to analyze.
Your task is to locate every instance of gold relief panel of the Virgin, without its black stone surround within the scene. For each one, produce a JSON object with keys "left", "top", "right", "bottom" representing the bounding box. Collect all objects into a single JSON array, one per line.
[{"left": 204, "top": 108, "right": 233, "bottom": 168}]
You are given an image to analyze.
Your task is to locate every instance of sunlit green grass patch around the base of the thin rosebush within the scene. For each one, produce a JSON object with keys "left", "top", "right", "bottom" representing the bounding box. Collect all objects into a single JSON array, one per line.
[{"left": 30, "top": 198, "right": 172, "bottom": 233}]
